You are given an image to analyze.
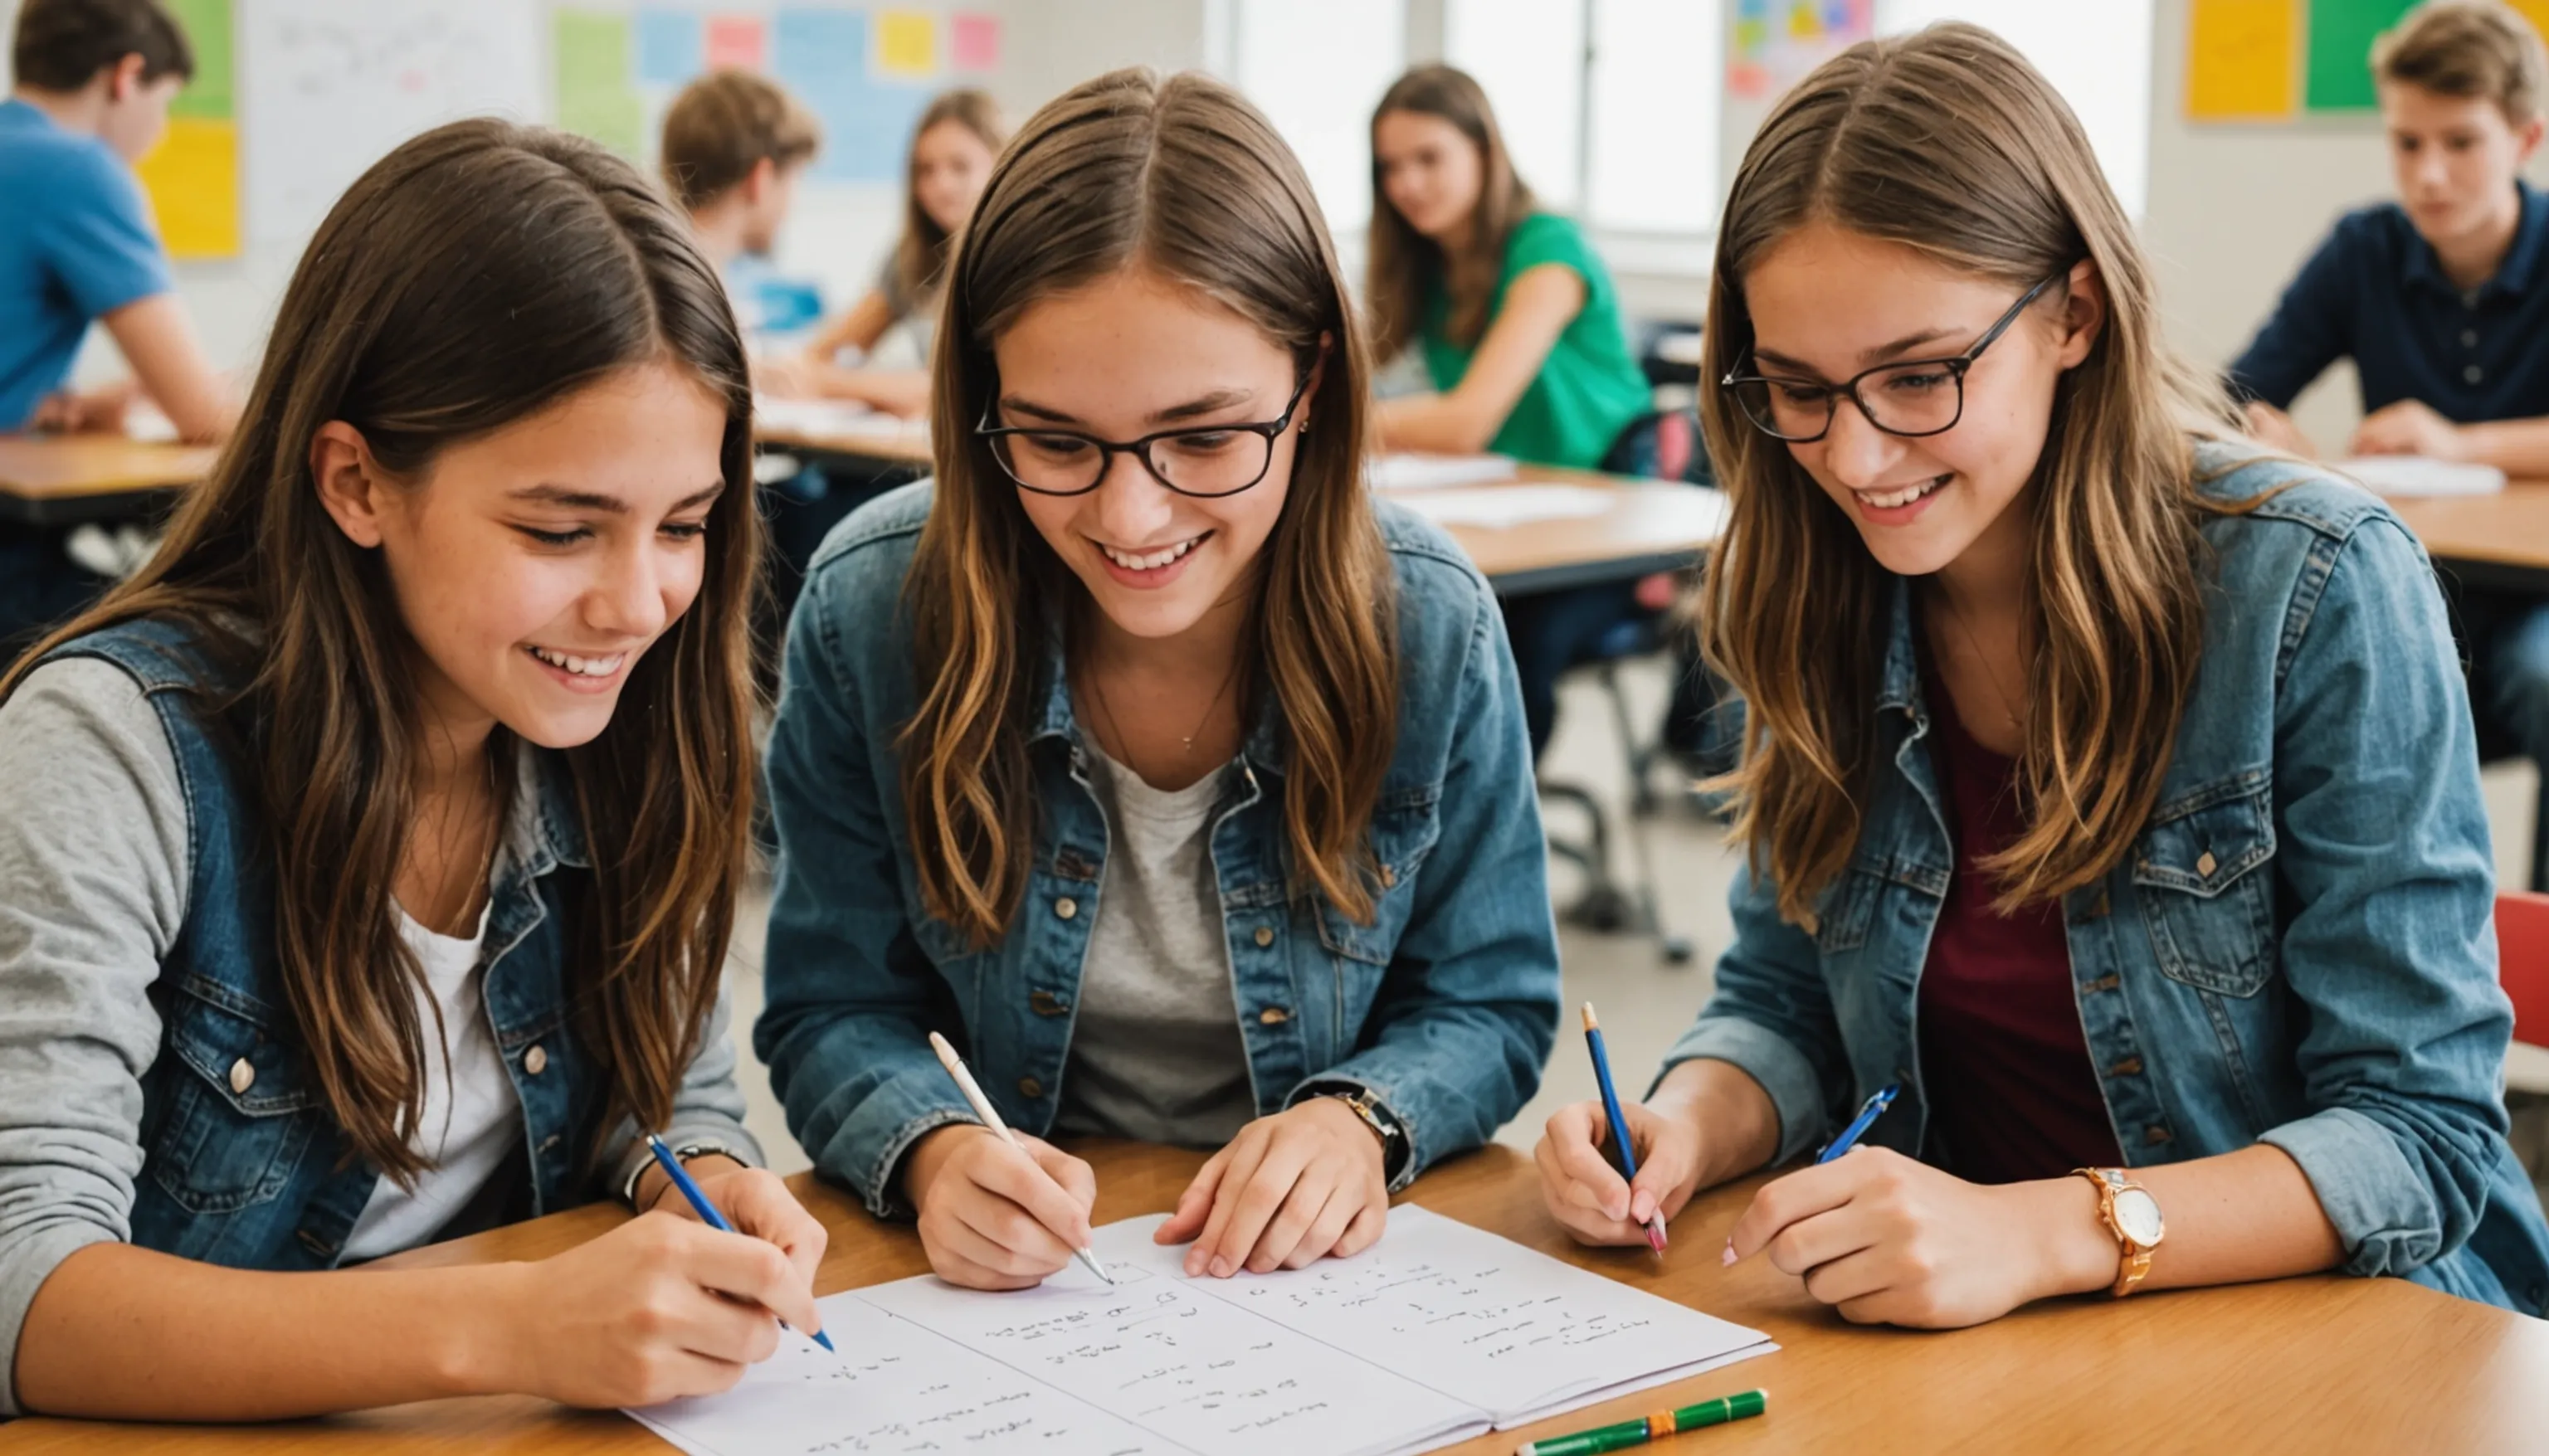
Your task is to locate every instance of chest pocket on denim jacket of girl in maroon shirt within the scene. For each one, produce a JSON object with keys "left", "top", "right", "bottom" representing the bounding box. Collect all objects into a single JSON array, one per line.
[{"left": 2133, "top": 770, "right": 2274, "bottom": 997}]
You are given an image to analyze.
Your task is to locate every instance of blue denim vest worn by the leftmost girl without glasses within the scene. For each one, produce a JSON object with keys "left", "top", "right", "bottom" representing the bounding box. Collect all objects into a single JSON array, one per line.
[{"left": 46, "top": 622, "right": 757, "bottom": 1270}]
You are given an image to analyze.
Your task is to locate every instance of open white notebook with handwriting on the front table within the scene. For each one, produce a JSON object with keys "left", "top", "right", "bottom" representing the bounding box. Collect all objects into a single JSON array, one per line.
[{"left": 630, "top": 1206, "right": 1777, "bottom": 1456}]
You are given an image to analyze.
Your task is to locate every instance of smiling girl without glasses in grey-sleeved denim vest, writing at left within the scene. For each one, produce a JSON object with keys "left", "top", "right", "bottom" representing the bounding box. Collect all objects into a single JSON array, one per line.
[{"left": 0, "top": 119, "right": 823, "bottom": 1420}]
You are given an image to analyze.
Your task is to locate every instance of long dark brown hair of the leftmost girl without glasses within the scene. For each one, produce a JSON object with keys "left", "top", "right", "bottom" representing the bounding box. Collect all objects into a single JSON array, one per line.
[{"left": 0, "top": 119, "right": 759, "bottom": 1181}]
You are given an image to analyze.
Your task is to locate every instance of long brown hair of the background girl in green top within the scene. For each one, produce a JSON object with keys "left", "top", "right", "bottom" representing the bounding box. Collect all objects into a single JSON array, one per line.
[{"left": 1364, "top": 66, "right": 1537, "bottom": 359}]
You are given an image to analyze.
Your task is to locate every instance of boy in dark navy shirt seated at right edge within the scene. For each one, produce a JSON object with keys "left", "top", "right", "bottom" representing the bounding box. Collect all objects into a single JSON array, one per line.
[{"left": 2230, "top": 0, "right": 2549, "bottom": 890}]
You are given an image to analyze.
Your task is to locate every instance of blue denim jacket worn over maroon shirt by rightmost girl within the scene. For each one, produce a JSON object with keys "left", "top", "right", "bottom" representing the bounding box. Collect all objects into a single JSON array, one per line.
[{"left": 1664, "top": 446, "right": 2549, "bottom": 1313}]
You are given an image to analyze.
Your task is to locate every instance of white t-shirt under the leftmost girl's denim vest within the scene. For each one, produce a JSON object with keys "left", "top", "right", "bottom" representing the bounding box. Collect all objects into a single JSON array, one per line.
[{"left": 344, "top": 910, "right": 523, "bottom": 1262}]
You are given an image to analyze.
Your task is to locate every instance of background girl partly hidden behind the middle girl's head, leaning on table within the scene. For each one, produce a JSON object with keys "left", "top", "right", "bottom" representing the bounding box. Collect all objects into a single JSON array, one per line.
[{"left": 772, "top": 87, "right": 1010, "bottom": 416}]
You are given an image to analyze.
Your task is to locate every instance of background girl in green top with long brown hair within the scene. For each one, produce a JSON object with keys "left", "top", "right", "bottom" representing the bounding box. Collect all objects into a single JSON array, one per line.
[{"left": 1364, "top": 66, "right": 1655, "bottom": 755}]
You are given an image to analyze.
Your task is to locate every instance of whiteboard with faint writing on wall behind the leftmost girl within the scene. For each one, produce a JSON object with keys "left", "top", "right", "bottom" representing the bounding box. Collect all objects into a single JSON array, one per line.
[{"left": 237, "top": 0, "right": 548, "bottom": 245}]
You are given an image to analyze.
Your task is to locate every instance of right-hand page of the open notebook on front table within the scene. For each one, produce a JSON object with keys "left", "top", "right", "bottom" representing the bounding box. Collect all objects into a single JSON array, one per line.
[{"left": 1198, "top": 1204, "right": 1772, "bottom": 1430}]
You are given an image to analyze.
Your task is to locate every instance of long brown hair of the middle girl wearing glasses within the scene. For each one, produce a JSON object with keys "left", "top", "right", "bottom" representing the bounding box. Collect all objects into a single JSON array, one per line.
[{"left": 899, "top": 71, "right": 1400, "bottom": 946}]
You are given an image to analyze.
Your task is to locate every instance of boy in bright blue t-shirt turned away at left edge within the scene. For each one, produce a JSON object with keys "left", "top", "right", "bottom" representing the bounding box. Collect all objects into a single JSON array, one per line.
[{"left": 0, "top": 0, "right": 232, "bottom": 650}]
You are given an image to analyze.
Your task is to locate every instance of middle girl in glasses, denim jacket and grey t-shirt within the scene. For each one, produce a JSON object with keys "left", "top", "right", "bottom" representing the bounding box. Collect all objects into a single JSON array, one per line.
[{"left": 754, "top": 71, "right": 1557, "bottom": 1288}]
